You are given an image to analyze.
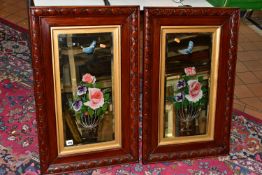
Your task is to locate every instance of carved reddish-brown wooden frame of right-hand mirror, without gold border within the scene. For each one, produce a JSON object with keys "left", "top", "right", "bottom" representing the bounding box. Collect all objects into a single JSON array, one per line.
[{"left": 142, "top": 8, "right": 239, "bottom": 163}]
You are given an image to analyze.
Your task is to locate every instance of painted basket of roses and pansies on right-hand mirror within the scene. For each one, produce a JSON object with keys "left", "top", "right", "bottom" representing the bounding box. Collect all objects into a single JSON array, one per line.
[{"left": 172, "top": 67, "right": 208, "bottom": 136}]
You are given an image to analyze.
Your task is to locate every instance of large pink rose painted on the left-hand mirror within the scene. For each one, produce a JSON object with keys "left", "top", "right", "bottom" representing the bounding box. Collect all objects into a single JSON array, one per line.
[{"left": 84, "top": 88, "right": 104, "bottom": 110}]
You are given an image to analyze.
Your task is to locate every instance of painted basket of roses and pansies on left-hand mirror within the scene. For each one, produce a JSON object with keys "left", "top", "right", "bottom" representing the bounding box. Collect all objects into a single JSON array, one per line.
[{"left": 71, "top": 73, "right": 111, "bottom": 143}]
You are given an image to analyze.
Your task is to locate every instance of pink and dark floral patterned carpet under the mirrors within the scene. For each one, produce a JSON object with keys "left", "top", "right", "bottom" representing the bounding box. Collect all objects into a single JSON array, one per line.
[{"left": 0, "top": 20, "right": 262, "bottom": 175}]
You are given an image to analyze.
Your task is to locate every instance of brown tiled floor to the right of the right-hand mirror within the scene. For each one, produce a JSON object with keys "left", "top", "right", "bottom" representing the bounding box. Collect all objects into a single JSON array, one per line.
[{"left": 234, "top": 20, "right": 262, "bottom": 119}]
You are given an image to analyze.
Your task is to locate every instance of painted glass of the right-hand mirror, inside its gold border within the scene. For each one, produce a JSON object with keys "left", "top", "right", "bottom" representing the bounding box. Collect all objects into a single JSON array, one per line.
[{"left": 163, "top": 32, "right": 212, "bottom": 138}]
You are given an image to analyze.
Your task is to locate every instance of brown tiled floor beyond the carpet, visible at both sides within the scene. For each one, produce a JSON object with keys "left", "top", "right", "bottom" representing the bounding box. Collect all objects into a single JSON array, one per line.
[{"left": 0, "top": 0, "right": 262, "bottom": 119}]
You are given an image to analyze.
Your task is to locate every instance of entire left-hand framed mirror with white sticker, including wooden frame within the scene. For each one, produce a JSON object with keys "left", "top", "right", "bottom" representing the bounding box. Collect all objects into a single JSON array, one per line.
[{"left": 30, "top": 7, "right": 139, "bottom": 174}]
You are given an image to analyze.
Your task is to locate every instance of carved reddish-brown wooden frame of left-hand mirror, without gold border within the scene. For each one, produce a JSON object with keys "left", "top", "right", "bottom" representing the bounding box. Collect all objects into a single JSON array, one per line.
[{"left": 29, "top": 6, "right": 139, "bottom": 174}]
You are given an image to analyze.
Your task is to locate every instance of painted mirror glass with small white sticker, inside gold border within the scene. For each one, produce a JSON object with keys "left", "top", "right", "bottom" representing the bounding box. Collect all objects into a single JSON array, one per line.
[{"left": 58, "top": 33, "right": 114, "bottom": 146}]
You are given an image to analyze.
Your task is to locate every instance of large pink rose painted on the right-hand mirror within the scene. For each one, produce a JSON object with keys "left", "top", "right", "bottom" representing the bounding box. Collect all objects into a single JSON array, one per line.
[{"left": 186, "top": 80, "right": 203, "bottom": 103}]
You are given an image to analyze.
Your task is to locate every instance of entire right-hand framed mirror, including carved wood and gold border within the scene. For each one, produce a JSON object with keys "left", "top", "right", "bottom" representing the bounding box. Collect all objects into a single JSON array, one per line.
[{"left": 143, "top": 8, "right": 239, "bottom": 163}]
